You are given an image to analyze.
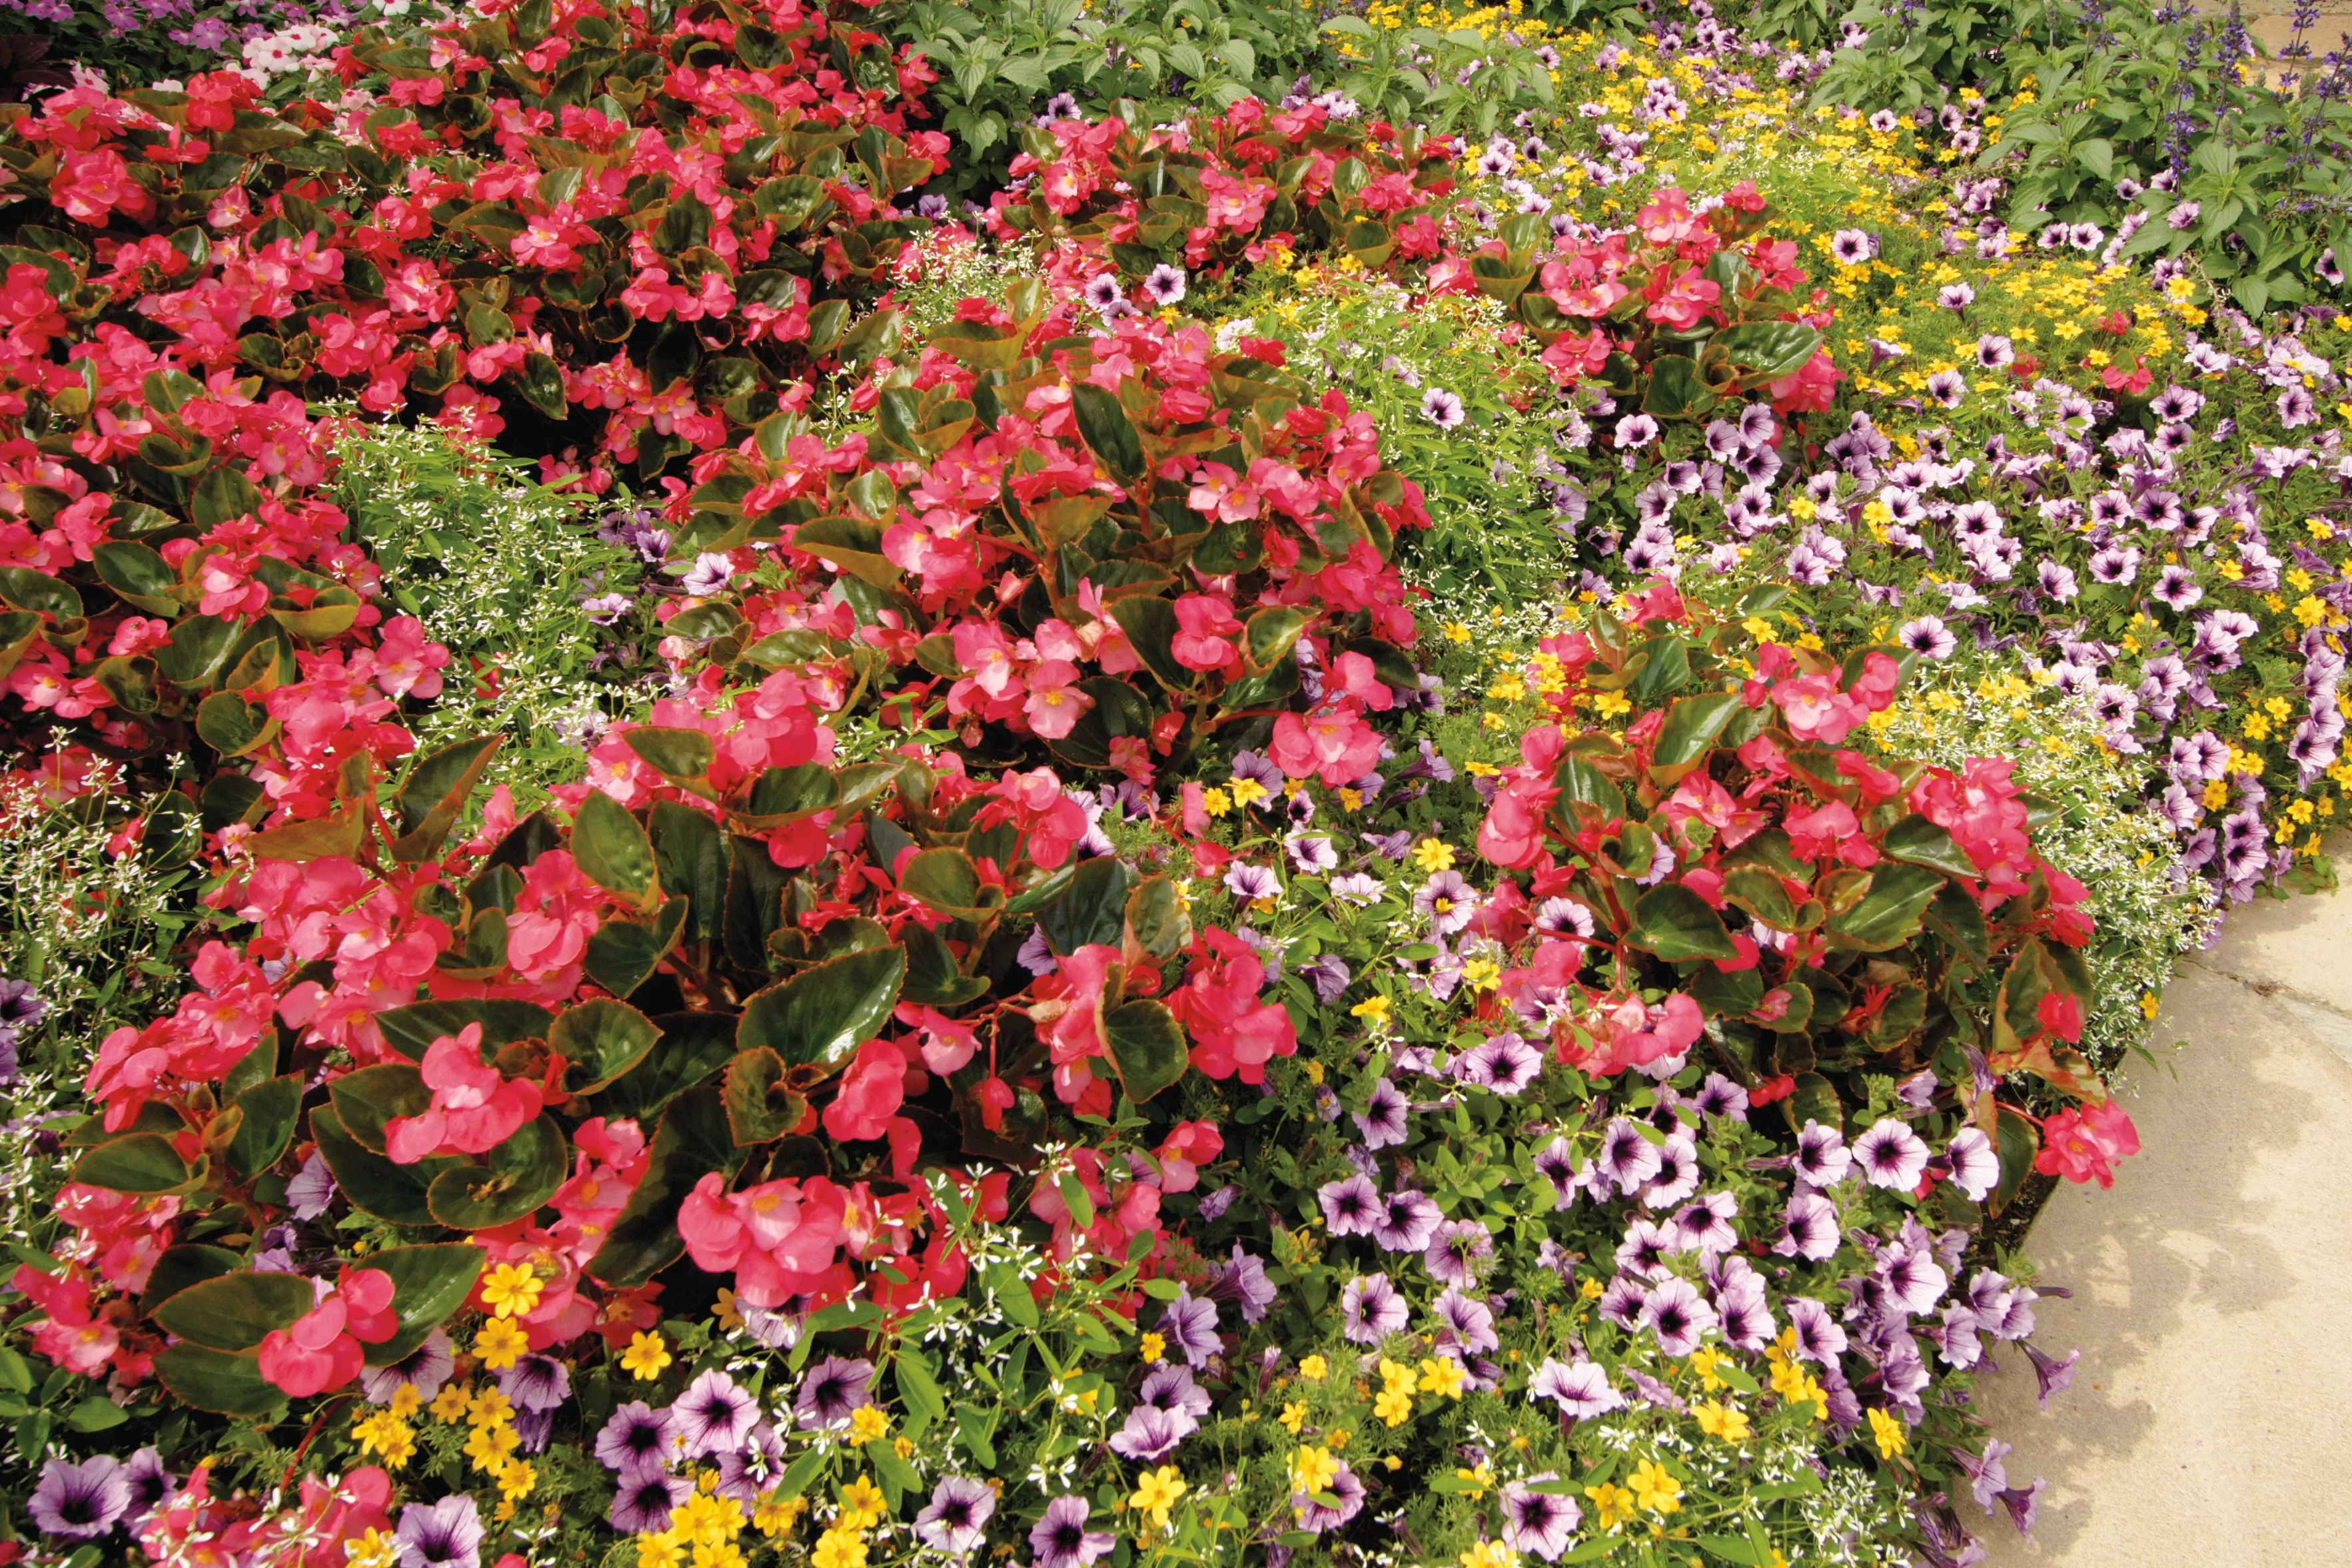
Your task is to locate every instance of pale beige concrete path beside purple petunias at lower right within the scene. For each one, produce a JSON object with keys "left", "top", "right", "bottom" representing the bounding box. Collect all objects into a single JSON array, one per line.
[{"left": 1962, "top": 841, "right": 2352, "bottom": 1568}]
